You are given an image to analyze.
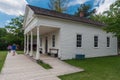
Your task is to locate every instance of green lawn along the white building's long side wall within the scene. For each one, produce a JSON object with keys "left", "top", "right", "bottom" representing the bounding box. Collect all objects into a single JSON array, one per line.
[{"left": 60, "top": 56, "right": 120, "bottom": 80}]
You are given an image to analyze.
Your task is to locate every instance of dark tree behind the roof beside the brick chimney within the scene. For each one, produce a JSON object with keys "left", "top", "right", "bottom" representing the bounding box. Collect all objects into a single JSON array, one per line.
[{"left": 74, "top": 4, "right": 95, "bottom": 17}]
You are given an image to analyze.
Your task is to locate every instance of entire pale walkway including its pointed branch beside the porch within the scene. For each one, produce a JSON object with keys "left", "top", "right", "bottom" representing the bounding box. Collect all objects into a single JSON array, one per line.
[{"left": 0, "top": 54, "right": 83, "bottom": 80}]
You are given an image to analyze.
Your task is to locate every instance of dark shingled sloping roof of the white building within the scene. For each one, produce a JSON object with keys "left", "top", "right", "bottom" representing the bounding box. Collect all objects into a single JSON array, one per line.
[{"left": 27, "top": 5, "right": 105, "bottom": 26}]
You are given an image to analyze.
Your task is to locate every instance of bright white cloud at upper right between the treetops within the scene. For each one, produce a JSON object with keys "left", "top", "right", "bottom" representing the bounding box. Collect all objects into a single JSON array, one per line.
[{"left": 97, "top": 0, "right": 116, "bottom": 14}]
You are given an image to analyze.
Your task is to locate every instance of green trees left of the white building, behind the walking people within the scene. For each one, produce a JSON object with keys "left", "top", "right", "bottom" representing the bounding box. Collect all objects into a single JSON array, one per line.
[{"left": 0, "top": 16, "right": 24, "bottom": 50}]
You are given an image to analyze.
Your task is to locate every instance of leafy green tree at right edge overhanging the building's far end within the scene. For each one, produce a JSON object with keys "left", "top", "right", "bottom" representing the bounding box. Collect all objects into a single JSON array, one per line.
[{"left": 104, "top": 0, "right": 120, "bottom": 39}]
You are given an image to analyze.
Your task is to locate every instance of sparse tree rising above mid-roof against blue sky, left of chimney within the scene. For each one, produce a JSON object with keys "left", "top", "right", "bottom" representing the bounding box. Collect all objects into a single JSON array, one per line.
[{"left": 48, "top": 0, "right": 68, "bottom": 13}]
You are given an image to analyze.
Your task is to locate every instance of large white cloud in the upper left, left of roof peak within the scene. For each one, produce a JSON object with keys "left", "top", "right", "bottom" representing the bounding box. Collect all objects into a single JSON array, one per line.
[{"left": 0, "top": 0, "right": 27, "bottom": 16}]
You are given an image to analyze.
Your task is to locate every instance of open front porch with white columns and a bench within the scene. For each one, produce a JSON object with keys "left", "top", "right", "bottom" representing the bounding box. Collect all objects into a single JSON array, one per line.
[{"left": 24, "top": 26, "right": 60, "bottom": 60}]
